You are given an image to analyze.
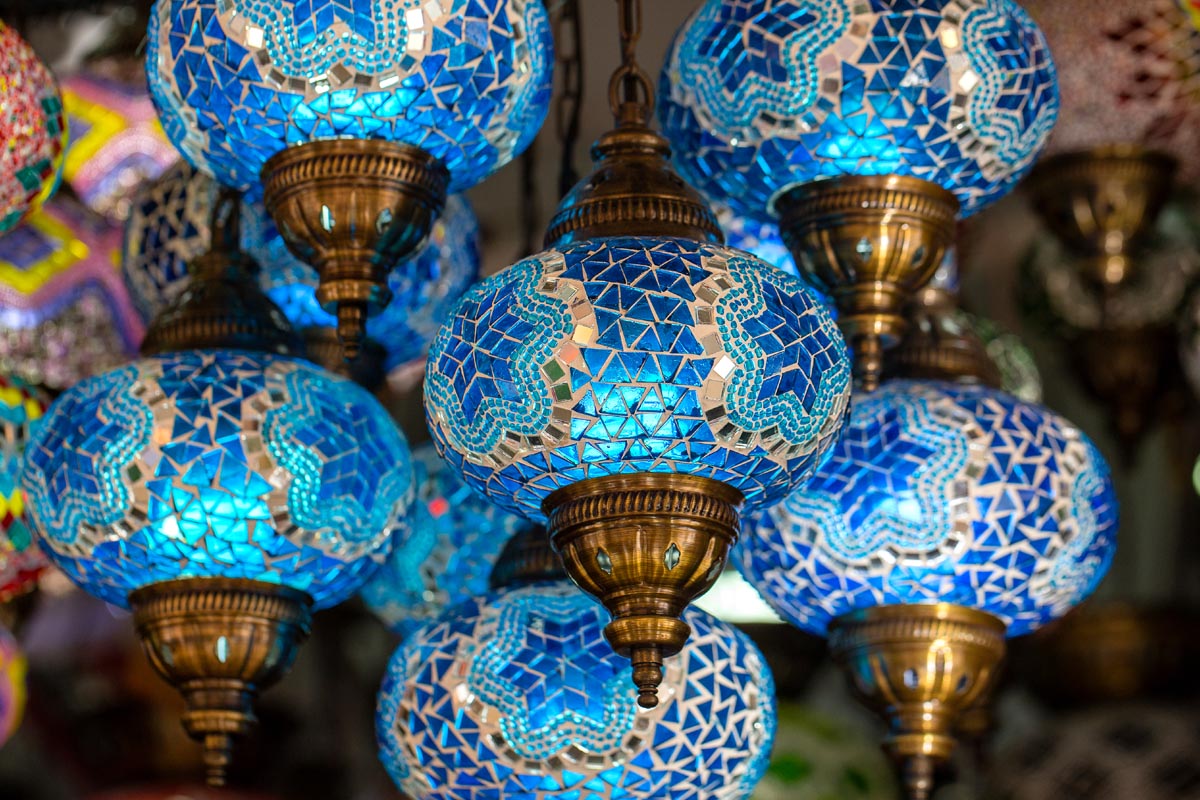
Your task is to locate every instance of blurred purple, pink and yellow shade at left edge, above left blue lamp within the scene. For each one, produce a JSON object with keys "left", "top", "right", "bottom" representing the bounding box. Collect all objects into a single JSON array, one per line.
[{"left": 0, "top": 197, "right": 144, "bottom": 390}]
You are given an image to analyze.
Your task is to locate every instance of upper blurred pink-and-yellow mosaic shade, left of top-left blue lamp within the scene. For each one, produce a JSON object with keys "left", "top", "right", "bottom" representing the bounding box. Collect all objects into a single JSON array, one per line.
[{"left": 62, "top": 65, "right": 179, "bottom": 223}]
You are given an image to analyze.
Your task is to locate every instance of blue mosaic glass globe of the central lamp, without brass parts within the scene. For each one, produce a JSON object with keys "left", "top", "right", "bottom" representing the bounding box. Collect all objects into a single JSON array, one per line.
[{"left": 425, "top": 237, "right": 850, "bottom": 521}]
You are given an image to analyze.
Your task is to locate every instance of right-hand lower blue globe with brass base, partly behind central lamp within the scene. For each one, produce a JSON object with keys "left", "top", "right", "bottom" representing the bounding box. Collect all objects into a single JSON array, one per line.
[{"left": 738, "top": 380, "right": 1117, "bottom": 798}]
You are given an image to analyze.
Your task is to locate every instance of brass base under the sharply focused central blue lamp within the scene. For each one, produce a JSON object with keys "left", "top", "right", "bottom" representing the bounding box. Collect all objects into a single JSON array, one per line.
[{"left": 542, "top": 473, "right": 743, "bottom": 708}]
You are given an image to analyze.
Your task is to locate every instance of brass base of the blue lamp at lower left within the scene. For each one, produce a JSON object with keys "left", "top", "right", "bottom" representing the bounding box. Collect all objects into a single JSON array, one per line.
[{"left": 130, "top": 578, "right": 312, "bottom": 787}]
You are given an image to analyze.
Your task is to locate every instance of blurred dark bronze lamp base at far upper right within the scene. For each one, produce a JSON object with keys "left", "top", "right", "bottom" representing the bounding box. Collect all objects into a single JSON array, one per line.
[{"left": 1027, "top": 146, "right": 1177, "bottom": 288}]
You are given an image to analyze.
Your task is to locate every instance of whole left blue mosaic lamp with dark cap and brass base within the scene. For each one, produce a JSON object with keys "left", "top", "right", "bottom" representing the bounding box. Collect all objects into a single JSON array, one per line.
[{"left": 16, "top": 185, "right": 414, "bottom": 784}]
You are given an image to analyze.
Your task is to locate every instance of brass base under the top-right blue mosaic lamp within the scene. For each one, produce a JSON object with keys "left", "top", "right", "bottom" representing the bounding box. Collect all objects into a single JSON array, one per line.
[{"left": 775, "top": 175, "right": 959, "bottom": 391}]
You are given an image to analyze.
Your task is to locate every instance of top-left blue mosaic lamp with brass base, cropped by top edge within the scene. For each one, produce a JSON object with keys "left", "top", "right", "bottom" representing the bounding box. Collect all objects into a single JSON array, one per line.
[{"left": 146, "top": 0, "right": 554, "bottom": 356}]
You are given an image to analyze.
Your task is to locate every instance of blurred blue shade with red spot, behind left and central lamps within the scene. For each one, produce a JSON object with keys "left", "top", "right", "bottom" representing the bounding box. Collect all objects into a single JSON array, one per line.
[{"left": 362, "top": 445, "right": 529, "bottom": 638}]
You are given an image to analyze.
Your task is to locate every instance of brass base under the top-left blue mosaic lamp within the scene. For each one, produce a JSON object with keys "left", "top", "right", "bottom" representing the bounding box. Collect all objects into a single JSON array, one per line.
[{"left": 262, "top": 139, "right": 450, "bottom": 359}]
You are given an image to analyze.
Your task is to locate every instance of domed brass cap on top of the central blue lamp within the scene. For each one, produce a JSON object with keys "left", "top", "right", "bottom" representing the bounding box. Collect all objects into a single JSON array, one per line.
[{"left": 546, "top": 122, "right": 725, "bottom": 247}]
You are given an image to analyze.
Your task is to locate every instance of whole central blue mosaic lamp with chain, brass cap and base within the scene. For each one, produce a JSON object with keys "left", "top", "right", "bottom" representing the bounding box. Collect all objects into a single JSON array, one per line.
[{"left": 425, "top": 0, "right": 850, "bottom": 708}]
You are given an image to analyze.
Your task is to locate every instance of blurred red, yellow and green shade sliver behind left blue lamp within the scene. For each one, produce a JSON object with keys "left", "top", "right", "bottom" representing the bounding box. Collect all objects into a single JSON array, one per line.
[{"left": 0, "top": 375, "right": 50, "bottom": 604}]
